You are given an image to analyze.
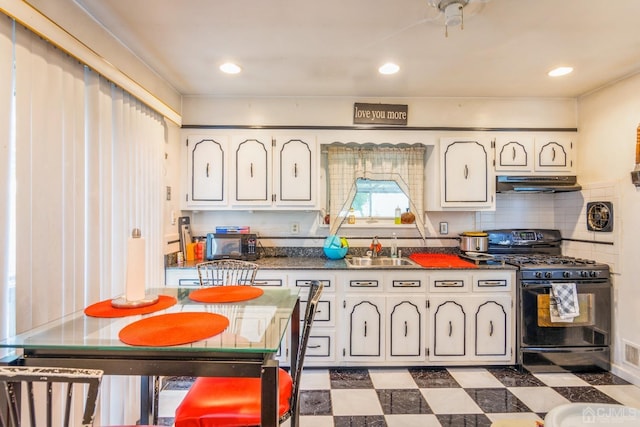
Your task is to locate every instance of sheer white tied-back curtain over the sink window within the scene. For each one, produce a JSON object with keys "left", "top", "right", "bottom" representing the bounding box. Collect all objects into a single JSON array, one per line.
[{"left": 327, "top": 143, "right": 425, "bottom": 238}]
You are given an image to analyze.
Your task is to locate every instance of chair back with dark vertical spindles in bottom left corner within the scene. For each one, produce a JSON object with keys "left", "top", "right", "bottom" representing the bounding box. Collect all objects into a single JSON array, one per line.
[{"left": 0, "top": 366, "right": 103, "bottom": 427}]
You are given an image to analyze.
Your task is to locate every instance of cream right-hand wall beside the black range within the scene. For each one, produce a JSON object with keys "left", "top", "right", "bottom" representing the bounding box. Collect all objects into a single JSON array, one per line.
[{"left": 576, "top": 75, "right": 640, "bottom": 384}]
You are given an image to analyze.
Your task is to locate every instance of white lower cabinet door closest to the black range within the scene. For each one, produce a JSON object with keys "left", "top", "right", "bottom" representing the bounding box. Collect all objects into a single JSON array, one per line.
[{"left": 474, "top": 296, "right": 511, "bottom": 358}]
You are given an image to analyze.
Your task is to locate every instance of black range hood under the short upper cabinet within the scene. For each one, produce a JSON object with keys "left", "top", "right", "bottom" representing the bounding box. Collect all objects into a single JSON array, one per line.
[{"left": 496, "top": 175, "right": 582, "bottom": 193}]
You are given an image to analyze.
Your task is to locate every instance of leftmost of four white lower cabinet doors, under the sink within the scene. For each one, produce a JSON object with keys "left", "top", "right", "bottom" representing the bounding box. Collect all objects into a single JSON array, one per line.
[{"left": 342, "top": 296, "right": 384, "bottom": 360}]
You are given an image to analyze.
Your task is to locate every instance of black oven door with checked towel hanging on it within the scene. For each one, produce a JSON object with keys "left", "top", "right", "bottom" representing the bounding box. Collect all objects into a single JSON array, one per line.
[{"left": 520, "top": 280, "right": 611, "bottom": 348}]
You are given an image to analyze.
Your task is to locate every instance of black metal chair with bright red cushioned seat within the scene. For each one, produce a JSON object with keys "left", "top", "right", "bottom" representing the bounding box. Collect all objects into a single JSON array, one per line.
[{"left": 175, "top": 281, "right": 324, "bottom": 427}]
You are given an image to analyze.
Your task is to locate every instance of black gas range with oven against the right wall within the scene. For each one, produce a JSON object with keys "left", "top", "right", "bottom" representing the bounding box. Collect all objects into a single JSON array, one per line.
[{"left": 486, "top": 229, "right": 611, "bottom": 372}]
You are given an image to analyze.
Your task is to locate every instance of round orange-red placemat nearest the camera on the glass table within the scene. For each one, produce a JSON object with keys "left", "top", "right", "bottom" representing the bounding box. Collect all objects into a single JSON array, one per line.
[{"left": 118, "top": 312, "right": 229, "bottom": 347}]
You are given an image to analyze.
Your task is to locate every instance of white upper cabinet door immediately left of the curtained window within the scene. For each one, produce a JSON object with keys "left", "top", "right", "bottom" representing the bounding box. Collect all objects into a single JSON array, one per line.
[{"left": 273, "top": 137, "right": 319, "bottom": 207}]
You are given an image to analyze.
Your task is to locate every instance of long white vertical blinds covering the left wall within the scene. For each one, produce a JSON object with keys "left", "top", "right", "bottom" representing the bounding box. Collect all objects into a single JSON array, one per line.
[{"left": 0, "top": 16, "right": 165, "bottom": 424}]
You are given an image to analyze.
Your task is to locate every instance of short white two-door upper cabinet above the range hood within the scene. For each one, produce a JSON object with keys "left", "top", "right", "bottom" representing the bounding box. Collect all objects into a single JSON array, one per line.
[{"left": 495, "top": 135, "right": 575, "bottom": 174}]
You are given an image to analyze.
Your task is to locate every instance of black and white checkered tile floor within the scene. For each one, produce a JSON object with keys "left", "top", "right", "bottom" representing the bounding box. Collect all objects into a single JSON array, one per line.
[{"left": 160, "top": 367, "right": 640, "bottom": 427}]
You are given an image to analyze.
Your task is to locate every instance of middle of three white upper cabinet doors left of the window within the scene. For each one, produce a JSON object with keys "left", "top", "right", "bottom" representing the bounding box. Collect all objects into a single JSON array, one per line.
[{"left": 233, "top": 137, "right": 271, "bottom": 206}]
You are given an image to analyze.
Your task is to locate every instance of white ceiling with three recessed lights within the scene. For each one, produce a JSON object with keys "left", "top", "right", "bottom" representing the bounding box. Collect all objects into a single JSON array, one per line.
[{"left": 77, "top": 0, "right": 640, "bottom": 97}]
